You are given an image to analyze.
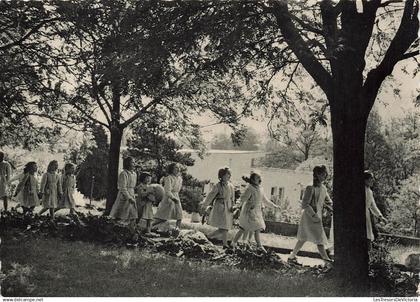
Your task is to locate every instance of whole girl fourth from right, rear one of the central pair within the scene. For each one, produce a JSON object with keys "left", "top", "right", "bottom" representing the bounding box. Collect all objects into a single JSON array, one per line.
[{"left": 201, "top": 168, "right": 235, "bottom": 248}]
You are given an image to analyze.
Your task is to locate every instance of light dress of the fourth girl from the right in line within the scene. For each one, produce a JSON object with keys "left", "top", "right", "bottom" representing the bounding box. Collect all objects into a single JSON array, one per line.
[{"left": 202, "top": 182, "right": 235, "bottom": 230}]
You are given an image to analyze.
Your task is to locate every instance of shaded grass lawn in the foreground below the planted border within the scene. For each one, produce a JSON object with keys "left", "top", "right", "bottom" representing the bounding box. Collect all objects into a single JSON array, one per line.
[{"left": 1, "top": 236, "right": 362, "bottom": 297}]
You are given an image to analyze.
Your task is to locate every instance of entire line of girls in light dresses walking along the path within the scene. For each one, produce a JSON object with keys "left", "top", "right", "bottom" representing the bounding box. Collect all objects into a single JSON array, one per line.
[{"left": 0, "top": 152, "right": 386, "bottom": 264}]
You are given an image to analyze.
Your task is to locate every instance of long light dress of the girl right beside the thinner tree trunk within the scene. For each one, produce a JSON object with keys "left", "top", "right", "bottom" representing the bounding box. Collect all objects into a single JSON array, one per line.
[{"left": 110, "top": 170, "right": 138, "bottom": 222}]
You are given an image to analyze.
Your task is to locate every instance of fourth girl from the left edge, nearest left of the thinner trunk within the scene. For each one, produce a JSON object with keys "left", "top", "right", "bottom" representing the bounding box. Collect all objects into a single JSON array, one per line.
[{"left": 55, "top": 163, "right": 76, "bottom": 215}]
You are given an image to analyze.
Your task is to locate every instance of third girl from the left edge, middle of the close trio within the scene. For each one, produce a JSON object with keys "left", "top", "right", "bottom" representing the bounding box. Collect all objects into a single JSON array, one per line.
[{"left": 39, "top": 160, "right": 63, "bottom": 219}]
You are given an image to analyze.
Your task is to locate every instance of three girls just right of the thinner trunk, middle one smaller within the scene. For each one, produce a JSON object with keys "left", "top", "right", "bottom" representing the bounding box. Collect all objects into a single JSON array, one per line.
[{"left": 110, "top": 157, "right": 182, "bottom": 233}]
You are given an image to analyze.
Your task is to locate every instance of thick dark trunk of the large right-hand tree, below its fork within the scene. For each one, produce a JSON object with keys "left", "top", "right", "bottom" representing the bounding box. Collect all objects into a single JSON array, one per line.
[{"left": 331, "top": 105, "right": 369, "bottom": 296}]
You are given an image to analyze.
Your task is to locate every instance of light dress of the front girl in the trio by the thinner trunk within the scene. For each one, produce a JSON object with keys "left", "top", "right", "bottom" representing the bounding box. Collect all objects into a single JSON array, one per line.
[{"left": 155, "top": 175, "right": 182, "bottom": 220}]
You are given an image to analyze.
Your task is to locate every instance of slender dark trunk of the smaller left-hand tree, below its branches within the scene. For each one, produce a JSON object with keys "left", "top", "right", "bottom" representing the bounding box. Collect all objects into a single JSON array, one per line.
[{"left": 104, "top": 127, "right": 123, "bottom": 215}]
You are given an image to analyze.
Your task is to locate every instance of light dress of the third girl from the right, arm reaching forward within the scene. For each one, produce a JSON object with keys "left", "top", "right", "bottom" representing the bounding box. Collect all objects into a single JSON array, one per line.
[{"left": 239, "top": 185, "right": 271, "bottom": 232}]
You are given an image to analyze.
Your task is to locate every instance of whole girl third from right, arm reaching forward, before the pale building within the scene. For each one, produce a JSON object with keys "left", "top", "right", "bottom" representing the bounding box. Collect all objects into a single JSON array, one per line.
[{"left": 232, "top": 172, "right": 280, "bottom": 252}]
